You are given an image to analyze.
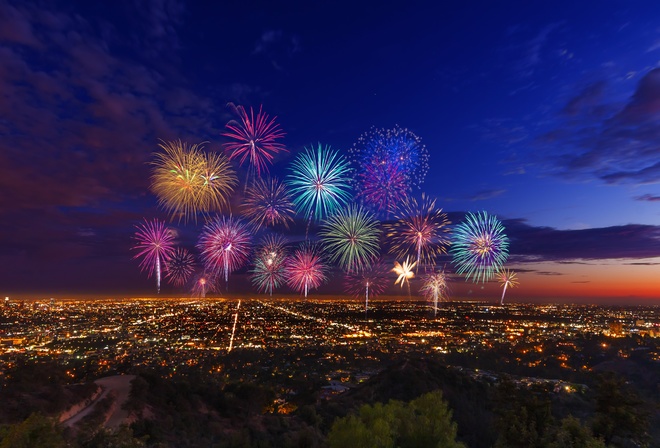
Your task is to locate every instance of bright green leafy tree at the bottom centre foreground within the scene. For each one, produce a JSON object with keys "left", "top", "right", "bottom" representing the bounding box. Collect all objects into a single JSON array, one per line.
[{"left": 328, "top": 390, "right": 463, "bottom": 448}]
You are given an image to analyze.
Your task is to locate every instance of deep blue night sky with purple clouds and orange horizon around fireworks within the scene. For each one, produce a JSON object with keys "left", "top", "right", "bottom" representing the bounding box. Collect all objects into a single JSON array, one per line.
[{"left": 0, "top": 0, "right": 660, "bottom": 303}]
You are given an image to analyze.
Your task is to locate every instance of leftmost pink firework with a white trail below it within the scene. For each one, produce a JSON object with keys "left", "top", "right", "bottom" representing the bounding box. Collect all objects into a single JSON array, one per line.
[{"left": 133, "top": 219, "right": 174, "bottom": 293}]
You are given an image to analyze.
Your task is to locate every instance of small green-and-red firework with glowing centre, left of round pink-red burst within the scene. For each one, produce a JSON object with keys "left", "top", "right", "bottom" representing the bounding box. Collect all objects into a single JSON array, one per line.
[{"left": 250, "top": 235, "right": 286, "bottom": 296}]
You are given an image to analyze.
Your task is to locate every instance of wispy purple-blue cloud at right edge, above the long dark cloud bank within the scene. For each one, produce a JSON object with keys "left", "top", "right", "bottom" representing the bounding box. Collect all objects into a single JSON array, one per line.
[{"left": 535, "top": 68, "right": 660, "bottom": 185}]
